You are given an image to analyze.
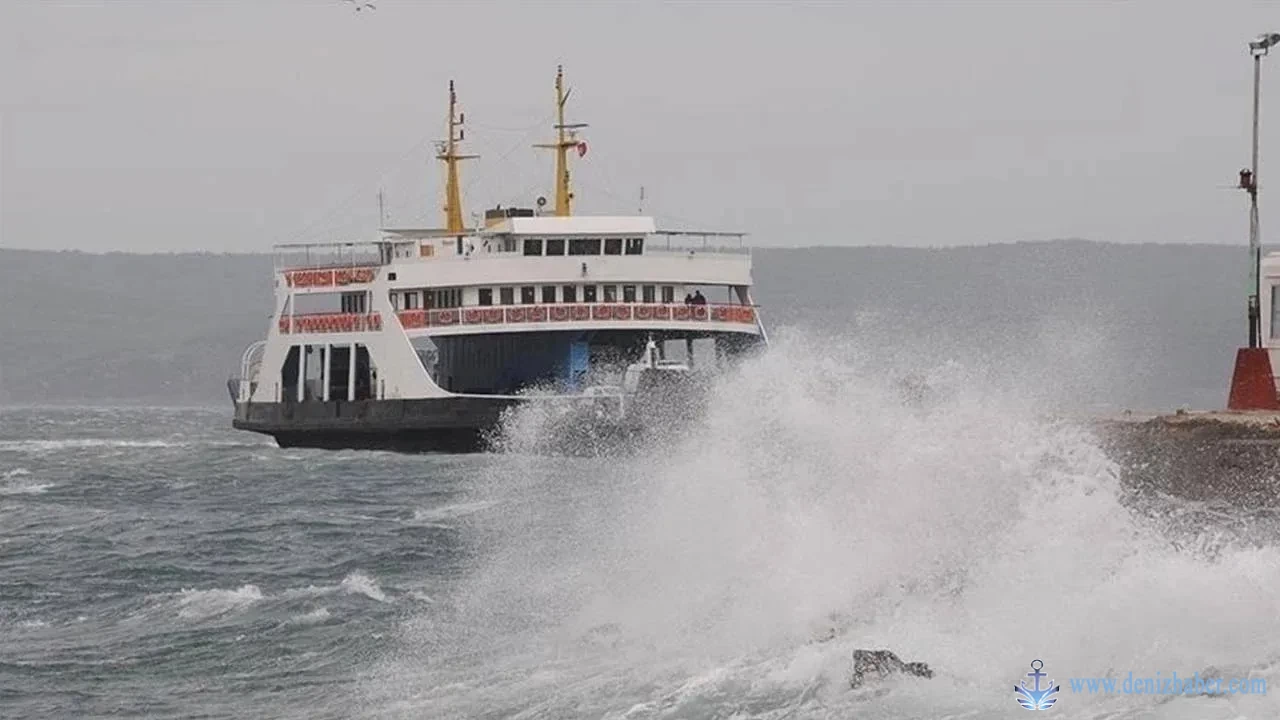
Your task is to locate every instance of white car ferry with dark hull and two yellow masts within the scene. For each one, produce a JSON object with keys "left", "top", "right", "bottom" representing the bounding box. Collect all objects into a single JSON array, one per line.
[{"left": 229, "top": 70, "right": 767, "bottom": 451}]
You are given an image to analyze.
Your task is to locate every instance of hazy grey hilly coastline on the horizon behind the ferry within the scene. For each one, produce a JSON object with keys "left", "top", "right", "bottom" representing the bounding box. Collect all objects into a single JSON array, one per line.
[{"left": 0, "top": 241, "right": 1247, "bottom": 410}]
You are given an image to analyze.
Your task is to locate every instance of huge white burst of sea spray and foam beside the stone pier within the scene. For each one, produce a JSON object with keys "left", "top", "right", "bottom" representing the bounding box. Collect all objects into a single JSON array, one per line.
[{"left": 366, "top": 340, "right": 1280, "bottom": 719}]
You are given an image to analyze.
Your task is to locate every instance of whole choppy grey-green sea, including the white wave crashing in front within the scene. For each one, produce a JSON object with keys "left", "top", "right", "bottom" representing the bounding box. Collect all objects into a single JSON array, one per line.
[{"left": 0, "top": 338, "right": 1280, "bottom": 720}]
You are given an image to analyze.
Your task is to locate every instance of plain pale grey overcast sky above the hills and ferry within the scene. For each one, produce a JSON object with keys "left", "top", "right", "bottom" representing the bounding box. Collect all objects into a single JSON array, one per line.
[{"left": 0, "top": 0, "right": 1280, "bottom": 251}]
